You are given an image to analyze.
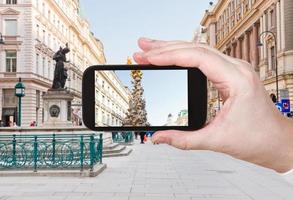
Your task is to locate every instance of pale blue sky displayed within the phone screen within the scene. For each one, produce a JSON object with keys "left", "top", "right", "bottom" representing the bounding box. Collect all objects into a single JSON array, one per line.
[{"left": 115, "top": 70, "right": 188, "bottom": 126}]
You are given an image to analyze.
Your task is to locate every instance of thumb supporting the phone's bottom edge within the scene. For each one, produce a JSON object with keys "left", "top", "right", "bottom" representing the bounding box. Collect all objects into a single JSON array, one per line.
[{"left": 152, "top": 128, "right": 210, "bottom": 150}]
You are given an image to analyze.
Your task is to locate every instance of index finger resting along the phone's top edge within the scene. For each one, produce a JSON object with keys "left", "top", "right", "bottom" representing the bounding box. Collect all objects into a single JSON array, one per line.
[{"left": 134, "top": 47, "right": 238, "bottom": 89}]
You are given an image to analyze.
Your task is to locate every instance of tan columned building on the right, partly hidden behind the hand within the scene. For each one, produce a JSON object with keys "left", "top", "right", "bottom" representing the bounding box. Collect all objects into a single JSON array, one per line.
[{"left": 201, "top": 0, "right": 293, "bottom": 119}]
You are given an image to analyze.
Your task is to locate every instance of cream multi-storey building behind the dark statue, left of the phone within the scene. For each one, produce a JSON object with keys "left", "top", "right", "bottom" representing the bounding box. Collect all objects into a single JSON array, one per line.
[{"left": 0, "top": 0, "right": 106, "bottom": 126}]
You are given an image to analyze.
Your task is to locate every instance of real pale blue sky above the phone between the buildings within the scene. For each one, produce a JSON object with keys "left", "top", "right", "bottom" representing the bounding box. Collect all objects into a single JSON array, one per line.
[{"left": 80, "top": 0, "right": 209, "bottom": 64}]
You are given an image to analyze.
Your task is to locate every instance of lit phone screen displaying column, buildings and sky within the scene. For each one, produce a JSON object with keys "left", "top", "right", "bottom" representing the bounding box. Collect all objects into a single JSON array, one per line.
[{"left": 94, "top": 69, "right": 188, "bottom": 127}]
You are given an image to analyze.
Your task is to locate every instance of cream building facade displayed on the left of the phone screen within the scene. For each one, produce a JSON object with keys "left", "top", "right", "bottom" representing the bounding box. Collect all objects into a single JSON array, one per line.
[{"left": 95, "top": 71, "right": 131, "bottom": 127}]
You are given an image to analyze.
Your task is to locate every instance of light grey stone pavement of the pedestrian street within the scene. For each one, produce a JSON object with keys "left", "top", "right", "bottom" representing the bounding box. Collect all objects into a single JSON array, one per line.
[{"left": 0, "top": 139, "right": 293, "bottom": 200}]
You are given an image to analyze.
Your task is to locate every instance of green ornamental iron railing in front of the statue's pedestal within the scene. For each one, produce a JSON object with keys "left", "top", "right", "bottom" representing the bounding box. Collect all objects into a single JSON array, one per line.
[{"left": 0, "top": 134, "right": 103, "bottom": 172}]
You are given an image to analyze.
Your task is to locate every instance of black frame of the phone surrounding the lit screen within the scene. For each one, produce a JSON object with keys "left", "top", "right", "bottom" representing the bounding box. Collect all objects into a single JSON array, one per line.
[{"left": 82, "top": 65, "right": 207, "bottom": 131}]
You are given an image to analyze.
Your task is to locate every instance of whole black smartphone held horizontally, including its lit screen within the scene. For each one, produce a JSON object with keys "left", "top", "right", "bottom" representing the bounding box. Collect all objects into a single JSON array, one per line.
[{"left": 82, "top": 65, "right": 207, "bottom": 131}]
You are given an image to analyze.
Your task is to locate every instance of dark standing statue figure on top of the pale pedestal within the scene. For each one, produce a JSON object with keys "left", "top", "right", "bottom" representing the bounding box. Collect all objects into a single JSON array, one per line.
[{"left": 52, "top": 43, "right": 70, "bottom": 89}]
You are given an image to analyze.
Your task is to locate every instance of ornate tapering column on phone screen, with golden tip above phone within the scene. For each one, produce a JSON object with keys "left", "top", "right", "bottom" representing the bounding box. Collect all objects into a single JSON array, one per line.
[{"left": 123, "top": 59, "right": 149, "bottom": 126}]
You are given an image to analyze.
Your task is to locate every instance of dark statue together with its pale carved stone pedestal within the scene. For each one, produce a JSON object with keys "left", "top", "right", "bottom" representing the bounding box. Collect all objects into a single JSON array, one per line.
[{"left": 43, "top": 44, "right": 74, "bottom": 127}]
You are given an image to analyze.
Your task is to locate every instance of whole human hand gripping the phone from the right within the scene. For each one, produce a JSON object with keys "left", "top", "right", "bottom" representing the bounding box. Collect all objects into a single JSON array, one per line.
[{"left": 134, "top": 38, "right": 293, "bottom": 172}]
